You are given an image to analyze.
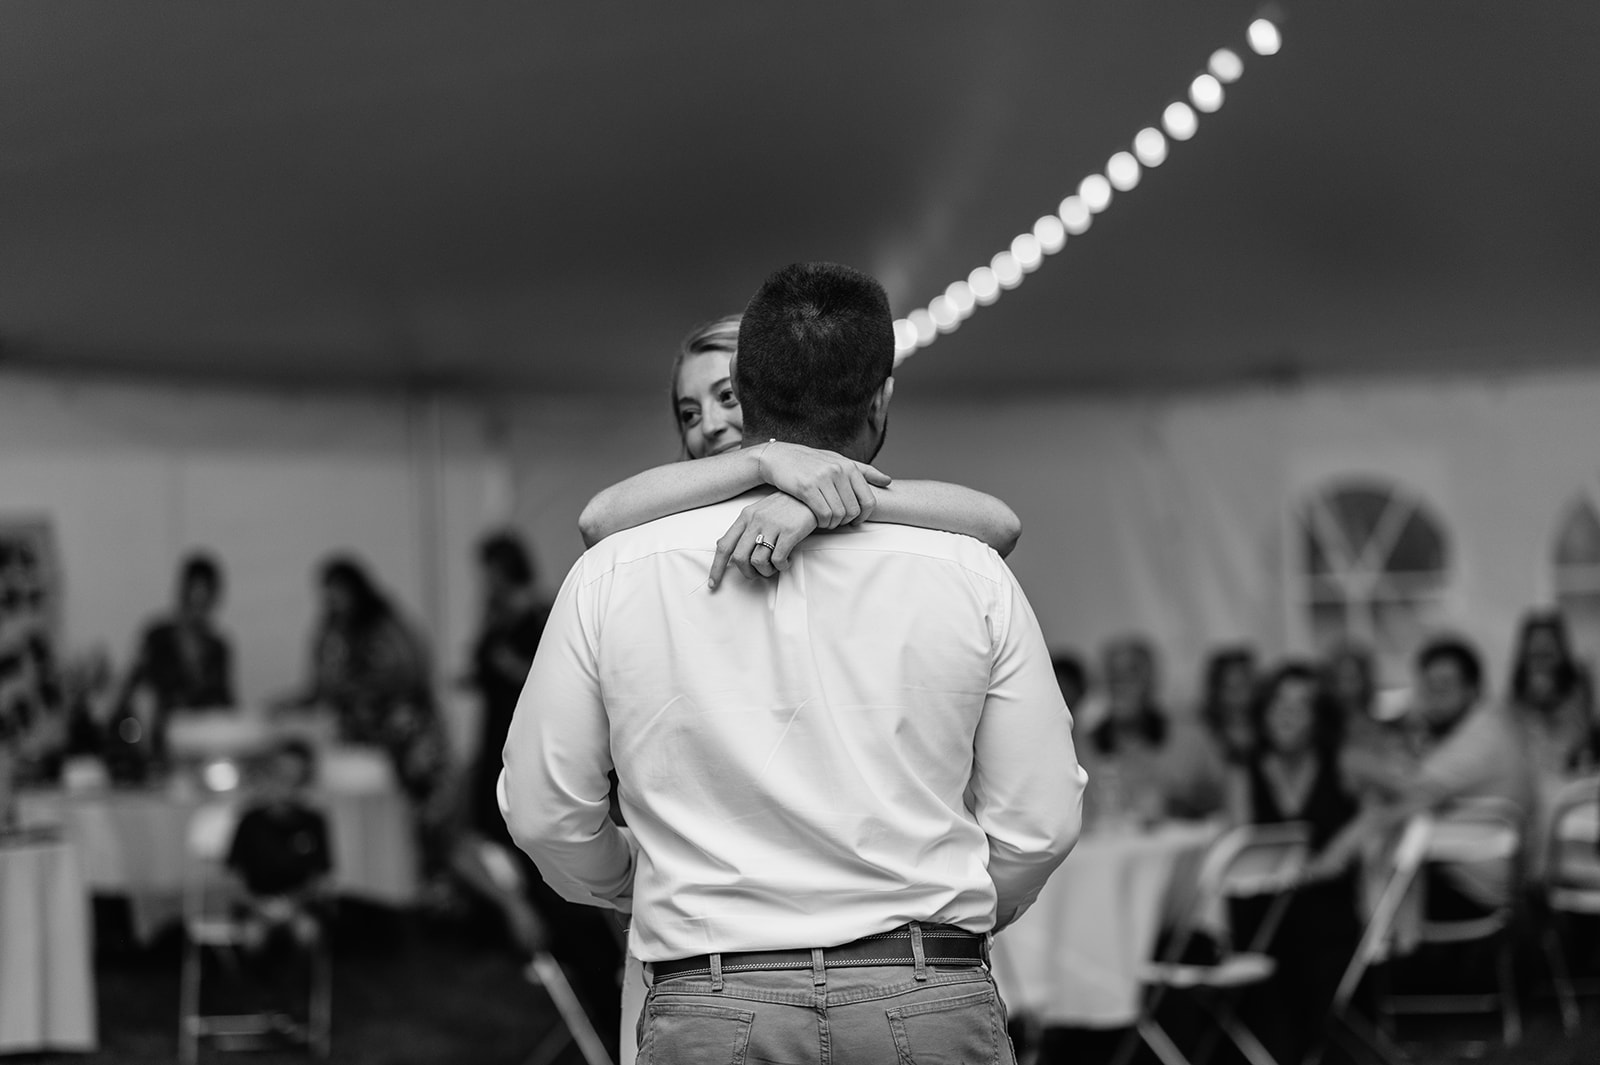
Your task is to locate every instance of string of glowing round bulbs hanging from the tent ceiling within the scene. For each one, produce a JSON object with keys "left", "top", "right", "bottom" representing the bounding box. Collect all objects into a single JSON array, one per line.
[{"left": 894, "top": 18, "right": 1283, "bottom": 366}]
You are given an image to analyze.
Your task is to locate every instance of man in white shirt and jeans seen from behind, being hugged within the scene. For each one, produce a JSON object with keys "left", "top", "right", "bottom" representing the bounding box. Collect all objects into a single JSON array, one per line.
[{"left": 502, "top": 264, "right": 1083, "bottom": 1065}]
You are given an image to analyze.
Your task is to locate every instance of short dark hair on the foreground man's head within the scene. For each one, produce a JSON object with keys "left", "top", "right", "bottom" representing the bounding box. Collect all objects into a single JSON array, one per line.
[{"left": 734, "top": 262, "right": 894, "bottom": 451}]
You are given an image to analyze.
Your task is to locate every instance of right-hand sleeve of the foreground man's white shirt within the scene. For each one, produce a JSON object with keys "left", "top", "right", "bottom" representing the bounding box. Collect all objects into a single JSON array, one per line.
[{"left": 970, "top": 569, "right": 1088, "bottom": 931}]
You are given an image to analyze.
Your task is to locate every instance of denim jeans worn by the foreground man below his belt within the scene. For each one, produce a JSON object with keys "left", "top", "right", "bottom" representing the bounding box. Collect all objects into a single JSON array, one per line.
[{"left": 638, "top": 964, "right": 1016, "bottom": 1065}]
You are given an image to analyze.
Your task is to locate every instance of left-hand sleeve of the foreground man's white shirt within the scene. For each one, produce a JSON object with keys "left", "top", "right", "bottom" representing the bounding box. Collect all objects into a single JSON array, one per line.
[{"left": 499, "top": 560, "right": 634, "bottom": 911}]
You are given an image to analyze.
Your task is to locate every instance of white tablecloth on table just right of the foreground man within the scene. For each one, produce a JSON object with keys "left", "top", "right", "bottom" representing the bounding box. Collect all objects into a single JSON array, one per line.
[{"left": 994, "top": 824, "right": 1221, "bottom": 1028}]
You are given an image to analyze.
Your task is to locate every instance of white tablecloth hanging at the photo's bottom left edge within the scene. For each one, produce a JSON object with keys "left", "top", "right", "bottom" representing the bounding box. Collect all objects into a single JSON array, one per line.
[{"left": 0, "top": 840, "right": 96, "bottom": 1054}]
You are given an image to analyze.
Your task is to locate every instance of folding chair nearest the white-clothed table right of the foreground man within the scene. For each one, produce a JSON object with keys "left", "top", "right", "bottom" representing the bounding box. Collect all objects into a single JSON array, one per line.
[{"left": 1114, "top": 824, "right": 1310, "bottom": 1065}]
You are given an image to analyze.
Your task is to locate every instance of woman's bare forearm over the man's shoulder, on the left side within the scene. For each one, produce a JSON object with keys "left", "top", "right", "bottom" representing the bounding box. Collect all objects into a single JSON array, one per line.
[{"left": 578, "top": 449, "right": 762, "bottom": 547}]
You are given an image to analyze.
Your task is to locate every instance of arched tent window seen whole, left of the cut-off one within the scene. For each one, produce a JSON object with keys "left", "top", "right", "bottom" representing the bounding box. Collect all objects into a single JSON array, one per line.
[{"left": 1296, "top": 477, "right": 1450, "bottom": 664}]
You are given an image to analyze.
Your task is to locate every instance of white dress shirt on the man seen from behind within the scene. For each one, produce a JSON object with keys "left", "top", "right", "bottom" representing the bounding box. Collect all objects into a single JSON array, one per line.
[{"left": 501, "top": 497, "right": 1085, "bottom": 961}]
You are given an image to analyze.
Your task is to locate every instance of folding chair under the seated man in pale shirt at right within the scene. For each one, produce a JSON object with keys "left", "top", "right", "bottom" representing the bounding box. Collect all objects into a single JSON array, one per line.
[{"left": 1378, "top": 798, "right": 1523, "bottom": 1046}]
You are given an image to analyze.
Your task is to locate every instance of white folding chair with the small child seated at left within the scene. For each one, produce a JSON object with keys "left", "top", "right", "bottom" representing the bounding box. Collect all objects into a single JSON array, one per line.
[{"left": 178, "top": 803, "right": 333, "bottom": 1065}]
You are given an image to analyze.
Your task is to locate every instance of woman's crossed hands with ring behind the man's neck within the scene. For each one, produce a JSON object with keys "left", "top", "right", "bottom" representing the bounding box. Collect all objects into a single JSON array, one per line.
[{"left": 709, "top": 441, "right": 891, "bottom": 588}]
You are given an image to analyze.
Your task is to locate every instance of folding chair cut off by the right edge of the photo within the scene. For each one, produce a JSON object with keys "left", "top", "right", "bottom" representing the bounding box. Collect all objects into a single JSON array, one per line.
[{"left": 1539, "top": 776, "right": 1600, "bottom": 1035}]
